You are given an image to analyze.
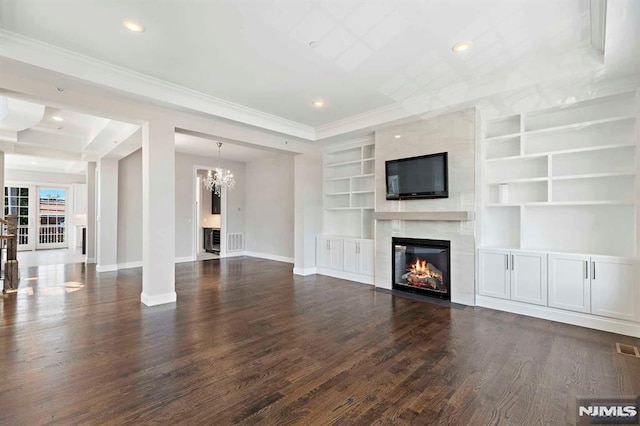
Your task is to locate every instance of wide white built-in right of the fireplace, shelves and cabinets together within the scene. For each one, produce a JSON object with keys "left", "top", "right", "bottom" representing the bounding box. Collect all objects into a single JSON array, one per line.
[{"left": 476, "top": 91, "right": 640, "bottom": 337}]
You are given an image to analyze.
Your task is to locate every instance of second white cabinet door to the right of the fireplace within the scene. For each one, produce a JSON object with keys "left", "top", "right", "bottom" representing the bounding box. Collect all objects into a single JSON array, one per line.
[{"left": 509, "top": 251, "right": 547, "bottom": 306}]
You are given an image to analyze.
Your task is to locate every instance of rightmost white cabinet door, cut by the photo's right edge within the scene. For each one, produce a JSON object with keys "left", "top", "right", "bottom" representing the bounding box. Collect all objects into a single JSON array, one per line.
[{"left": 591, "top": 256, "right": 638, "bottom": 321}]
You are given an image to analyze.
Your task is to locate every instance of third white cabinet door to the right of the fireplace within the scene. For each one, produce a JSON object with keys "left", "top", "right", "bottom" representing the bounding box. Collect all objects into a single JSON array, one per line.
[{"left": 549, "top": 254, "right": 591, "bottom": 312}]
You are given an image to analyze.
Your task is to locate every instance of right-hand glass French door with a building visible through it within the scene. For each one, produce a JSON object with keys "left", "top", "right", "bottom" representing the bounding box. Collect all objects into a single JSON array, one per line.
[{"left": 36, "top": 187, "right": 69, "bottom": 249}]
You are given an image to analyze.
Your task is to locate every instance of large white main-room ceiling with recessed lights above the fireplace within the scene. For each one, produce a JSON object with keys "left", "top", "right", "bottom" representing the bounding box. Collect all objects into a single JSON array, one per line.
[{"left": 0, "top": 0, "right": 638, "bottom": 131}]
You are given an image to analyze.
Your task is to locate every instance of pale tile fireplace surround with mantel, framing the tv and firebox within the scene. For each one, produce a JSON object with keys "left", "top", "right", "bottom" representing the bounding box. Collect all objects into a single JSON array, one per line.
[{"left": 375, "top": 109, "right": 476, "bottom": 305}]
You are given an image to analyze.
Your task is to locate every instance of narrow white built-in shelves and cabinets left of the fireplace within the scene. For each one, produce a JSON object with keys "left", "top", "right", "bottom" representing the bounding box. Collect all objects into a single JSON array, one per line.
[{"left": 316, "top": 139, "right": 375, "bottom": 284}]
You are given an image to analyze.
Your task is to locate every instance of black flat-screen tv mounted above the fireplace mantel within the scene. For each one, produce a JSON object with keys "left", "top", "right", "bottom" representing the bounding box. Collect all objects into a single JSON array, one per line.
[{"left": 386, "top": 152, "right": 449, "bottom": 200}]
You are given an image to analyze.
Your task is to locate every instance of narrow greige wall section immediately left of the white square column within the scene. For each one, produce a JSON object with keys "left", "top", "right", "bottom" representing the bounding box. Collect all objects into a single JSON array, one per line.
[{"left": 118, "top": 149, "right": 142, "bottom": 265}]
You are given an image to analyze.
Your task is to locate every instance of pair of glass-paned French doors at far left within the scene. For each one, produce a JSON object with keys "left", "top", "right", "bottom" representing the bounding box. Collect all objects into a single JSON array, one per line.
[{"left": 4, "top": 185, "right": 69, "bottom": 250}]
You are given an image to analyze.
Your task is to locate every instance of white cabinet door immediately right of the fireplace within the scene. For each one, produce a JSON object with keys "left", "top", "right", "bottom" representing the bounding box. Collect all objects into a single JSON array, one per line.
[{"left": 478, "top": 250, "right": 511, "bottom": 299}]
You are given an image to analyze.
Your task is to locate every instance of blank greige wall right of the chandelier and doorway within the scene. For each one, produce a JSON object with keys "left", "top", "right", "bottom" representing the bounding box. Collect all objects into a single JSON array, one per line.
[{"left": 245, "top": 154, "right": 294, "bottom": 263}]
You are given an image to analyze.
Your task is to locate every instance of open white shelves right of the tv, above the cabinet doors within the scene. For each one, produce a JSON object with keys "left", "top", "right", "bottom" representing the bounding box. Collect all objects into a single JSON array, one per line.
[{"left": 480, "top": 91, "right": 640, "bottom": 257}]
